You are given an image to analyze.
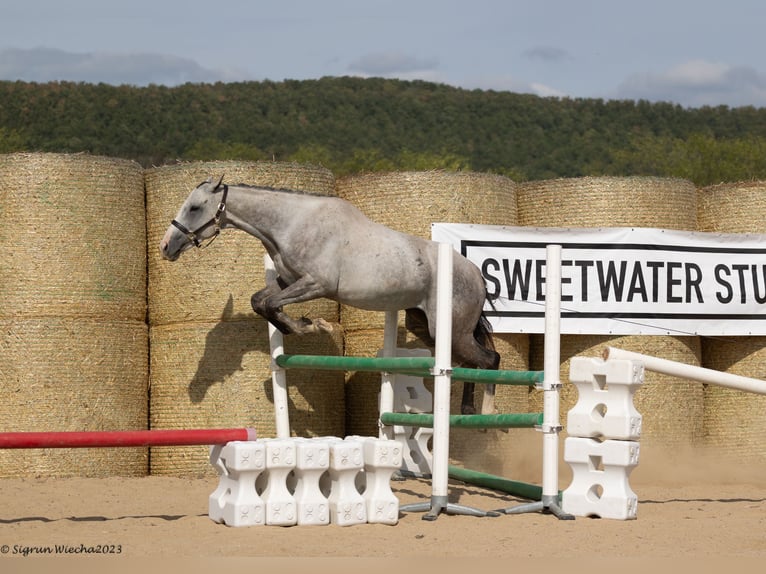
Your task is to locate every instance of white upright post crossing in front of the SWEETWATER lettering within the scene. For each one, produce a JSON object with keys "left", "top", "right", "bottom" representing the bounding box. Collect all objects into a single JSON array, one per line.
[{"left": 541, "top": 245, "right": 565, "bottom": 518}]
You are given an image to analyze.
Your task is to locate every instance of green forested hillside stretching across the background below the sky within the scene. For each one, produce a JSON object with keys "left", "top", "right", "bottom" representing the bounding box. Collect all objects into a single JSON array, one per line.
[{"left": 0, "top": 77, "right": 766, "bottom": 186}]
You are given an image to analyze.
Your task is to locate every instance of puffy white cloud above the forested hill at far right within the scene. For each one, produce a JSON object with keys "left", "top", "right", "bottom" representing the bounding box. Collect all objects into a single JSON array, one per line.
[{"left": 617, "top": 60, "right": 766, "bottom": 107}]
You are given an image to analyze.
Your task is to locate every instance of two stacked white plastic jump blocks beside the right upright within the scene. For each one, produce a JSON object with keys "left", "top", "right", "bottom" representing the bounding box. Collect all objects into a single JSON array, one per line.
[{"left": 561, "top": 357, "right": 644, "bottom": 520}]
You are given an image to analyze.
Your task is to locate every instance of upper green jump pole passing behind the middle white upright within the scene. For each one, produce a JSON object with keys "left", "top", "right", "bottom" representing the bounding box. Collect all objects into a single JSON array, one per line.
[{"left": 276, "top": 355, "right": 543, "bottom": 386}]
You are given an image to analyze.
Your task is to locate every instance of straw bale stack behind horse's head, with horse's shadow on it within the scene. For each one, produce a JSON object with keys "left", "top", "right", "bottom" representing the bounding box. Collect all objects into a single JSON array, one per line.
[{"left": 145, "top": 161, "right": 344, "bottom": 475}]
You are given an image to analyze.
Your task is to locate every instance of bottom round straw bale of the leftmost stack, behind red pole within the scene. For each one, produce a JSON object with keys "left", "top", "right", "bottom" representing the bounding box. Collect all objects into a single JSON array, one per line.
[{"left": 0, "top": 317, "right": 148, "bottom": 478}]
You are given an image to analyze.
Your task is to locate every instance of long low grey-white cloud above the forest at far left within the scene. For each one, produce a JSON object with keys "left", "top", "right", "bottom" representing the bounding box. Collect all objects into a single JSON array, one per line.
[{"left": 0, "top": 48, "right": 247, "bottom": 86}]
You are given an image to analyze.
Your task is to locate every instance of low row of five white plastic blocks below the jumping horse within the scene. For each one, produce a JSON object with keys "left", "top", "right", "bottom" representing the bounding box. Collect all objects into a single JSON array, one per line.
[{"left": 208, "top": 437, "right": 402, "bottom": 526}]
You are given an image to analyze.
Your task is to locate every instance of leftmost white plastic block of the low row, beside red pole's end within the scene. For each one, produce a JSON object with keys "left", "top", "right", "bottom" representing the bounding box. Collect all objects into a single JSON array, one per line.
[{"left": 208, "top": 441, "right": 266, "bottom": 526}]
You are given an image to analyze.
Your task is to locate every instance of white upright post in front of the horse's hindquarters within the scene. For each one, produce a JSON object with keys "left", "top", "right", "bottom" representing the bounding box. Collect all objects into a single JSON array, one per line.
[{"left": 431, "top": 243, "right": 452, "bottom": 513}]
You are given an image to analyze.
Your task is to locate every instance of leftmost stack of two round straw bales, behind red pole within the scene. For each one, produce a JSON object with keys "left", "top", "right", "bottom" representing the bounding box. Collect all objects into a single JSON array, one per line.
[{"left": 0, "top": 153, "right": 148, "bottom": 477}]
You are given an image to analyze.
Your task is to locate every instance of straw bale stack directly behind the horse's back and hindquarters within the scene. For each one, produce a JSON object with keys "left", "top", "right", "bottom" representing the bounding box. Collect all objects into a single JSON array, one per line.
[{"left": 336, "top": 171, "right": 528, "bottom": 471}]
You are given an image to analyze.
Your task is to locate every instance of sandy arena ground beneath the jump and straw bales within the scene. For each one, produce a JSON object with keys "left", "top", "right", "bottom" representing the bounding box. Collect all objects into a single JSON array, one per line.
[{"left": 0, "top": 453, "right": 766, "bottom": 572}]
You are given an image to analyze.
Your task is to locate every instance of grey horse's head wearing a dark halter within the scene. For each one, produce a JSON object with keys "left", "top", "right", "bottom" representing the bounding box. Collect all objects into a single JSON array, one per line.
[{"left": 160, "top": 176, "right": 229, "bottom": 261}]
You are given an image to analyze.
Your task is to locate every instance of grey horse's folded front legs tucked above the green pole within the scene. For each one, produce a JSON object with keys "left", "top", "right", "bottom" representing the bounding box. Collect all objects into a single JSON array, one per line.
[{"left": 250, "top": 276, "right": 333, "bottom": 335}]
